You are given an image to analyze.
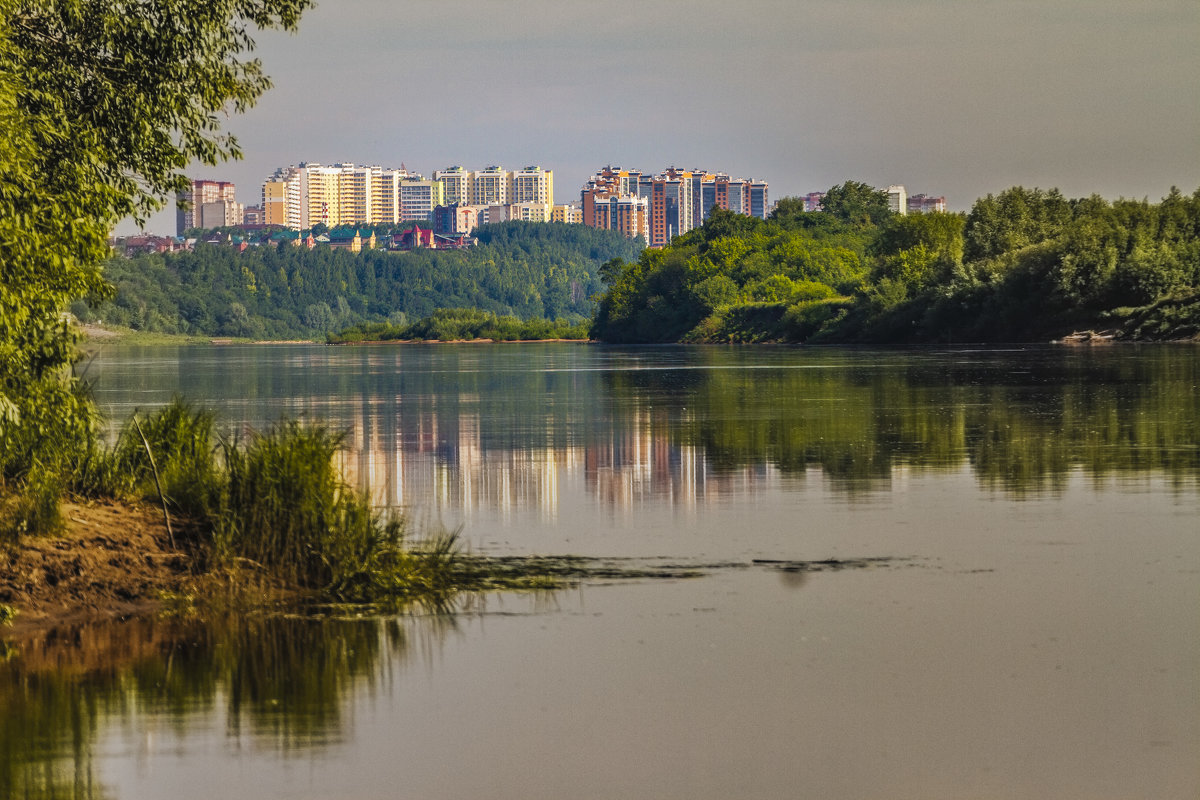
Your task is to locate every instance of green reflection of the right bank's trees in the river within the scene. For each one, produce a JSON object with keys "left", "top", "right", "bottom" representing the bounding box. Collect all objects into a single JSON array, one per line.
[{"left": 606, "top": 347, "right": 1200, "bottom": 493}]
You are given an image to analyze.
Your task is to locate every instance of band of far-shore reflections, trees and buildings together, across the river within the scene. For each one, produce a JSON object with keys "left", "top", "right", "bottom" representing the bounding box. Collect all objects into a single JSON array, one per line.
[{"left": 97, "top": 344, "right": 1200, "bottom": 515}]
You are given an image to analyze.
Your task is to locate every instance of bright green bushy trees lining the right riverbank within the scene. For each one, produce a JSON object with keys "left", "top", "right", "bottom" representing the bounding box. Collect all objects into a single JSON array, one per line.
[{"left": 592, "top": 181, "right": 1200, "bottom": 343}]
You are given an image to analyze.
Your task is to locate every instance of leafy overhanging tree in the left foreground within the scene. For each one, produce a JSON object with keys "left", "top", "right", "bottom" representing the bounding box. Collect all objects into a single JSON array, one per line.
[{"left": 0, "top": 0, "right": 312, "bottom": 531}]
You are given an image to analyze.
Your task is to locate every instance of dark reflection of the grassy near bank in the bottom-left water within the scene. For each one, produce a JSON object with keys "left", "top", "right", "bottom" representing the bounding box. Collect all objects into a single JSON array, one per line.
[{"left": 0, "top": 618, "right": 420, "bottom": 798}]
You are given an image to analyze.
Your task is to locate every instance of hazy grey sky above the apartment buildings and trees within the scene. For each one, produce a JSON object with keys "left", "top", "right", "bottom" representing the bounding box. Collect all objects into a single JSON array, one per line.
[{"left": 118, "top": 0, "right": 1200, "bottom": 234}]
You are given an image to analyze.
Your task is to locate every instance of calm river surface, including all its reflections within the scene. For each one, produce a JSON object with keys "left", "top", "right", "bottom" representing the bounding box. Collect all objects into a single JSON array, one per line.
[{"left": 0, "top": 344, "right": 1200, "bottom": 799}]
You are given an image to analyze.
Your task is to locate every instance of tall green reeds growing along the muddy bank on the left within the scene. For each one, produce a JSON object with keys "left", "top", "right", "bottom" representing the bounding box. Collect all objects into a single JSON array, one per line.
[{"left": 7, "top": 397, "right": 580, "bottom": 609}]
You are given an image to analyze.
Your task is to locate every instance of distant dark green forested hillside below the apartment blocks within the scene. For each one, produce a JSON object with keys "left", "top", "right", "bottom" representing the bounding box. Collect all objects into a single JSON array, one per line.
[{"left": 84, "top": 222, "right": 641, "bottom": 338}]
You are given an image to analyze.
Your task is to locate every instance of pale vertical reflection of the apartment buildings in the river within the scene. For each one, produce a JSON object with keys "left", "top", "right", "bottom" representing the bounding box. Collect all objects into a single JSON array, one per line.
[{"left": 274, "top": 396, "right": 776, "bottom": 522}]
